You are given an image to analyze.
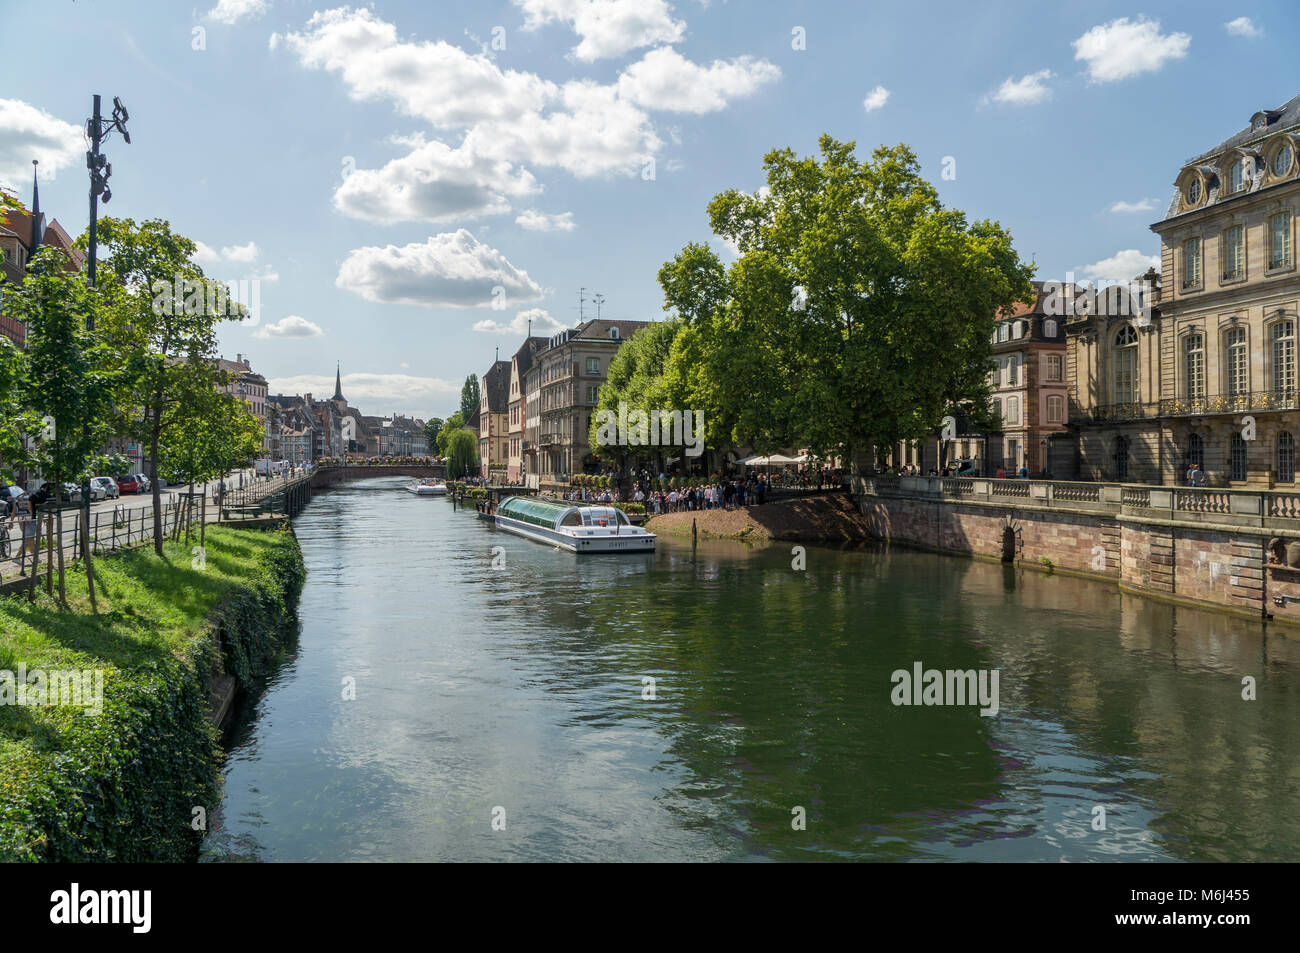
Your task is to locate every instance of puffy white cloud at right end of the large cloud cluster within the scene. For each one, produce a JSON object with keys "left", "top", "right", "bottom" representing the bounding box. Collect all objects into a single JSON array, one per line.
[{"left": 619, "top": 47, "right": 780, "bottom": 114}]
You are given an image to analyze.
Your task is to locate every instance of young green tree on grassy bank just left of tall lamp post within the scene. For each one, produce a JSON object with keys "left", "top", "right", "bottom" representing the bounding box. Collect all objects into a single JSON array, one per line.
[{"left": 8, "top": 248, "right": 122, "bottom": 606}]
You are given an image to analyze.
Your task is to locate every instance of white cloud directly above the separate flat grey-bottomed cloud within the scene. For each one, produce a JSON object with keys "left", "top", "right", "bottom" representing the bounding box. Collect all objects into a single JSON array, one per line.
[{"left": 334, "top": 137, "right": 541, "bottom": 225}]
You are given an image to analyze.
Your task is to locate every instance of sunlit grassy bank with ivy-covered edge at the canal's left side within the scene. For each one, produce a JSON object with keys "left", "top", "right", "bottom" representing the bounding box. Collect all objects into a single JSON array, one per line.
[{"left": 0, "top": 528, "right": 304, "bottom": 861}]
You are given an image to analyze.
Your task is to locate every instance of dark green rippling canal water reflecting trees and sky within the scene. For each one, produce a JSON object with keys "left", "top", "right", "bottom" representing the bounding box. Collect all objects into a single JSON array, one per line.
[{"left": 203, "top": 480, "right": 1300, "bottom": 861}]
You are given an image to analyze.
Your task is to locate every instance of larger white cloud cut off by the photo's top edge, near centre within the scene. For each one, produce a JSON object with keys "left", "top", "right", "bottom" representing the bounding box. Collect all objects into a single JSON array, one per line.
[{"left": 515, "top": 0, "right": 686, "bottom": 62}]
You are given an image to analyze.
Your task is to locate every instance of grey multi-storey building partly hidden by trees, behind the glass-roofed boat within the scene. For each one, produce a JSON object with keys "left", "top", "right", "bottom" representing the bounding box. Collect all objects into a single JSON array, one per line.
[{"left": 525, "top": 319, "right": 647, "bottom": 494}]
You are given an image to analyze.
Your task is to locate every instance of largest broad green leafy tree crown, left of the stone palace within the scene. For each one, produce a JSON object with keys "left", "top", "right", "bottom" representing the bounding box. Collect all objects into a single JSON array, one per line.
[{"left": 659, "top": 135, "right": 1034, "bottom": 464}]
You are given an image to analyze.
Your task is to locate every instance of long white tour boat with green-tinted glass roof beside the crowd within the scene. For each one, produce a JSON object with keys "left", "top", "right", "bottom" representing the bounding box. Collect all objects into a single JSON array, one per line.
[{"left": 495, "top": 497, "right": 655, "bottom": 553}]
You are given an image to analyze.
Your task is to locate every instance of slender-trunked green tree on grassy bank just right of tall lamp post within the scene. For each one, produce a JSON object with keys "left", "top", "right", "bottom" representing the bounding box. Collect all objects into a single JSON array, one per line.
[{"left": 77, "top": 218, "right": 244, "bottom": 555}]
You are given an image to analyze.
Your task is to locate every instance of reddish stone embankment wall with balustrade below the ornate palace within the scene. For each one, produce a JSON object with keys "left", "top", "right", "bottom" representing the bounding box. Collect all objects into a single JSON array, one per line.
[{"left": 854, "top": 477, "right": 1300, "bottom": 623}]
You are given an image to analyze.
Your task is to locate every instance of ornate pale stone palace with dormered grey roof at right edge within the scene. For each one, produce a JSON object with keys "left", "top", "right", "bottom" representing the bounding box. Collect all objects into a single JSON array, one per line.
[{"left": 1066, "top": 96, "right": 1300, "bottom": 486}]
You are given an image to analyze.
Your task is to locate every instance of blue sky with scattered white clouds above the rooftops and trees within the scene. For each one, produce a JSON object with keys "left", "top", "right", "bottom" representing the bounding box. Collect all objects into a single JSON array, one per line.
[{"left": 0, "top": 0, "right": 1300, "bottom": 417}]
